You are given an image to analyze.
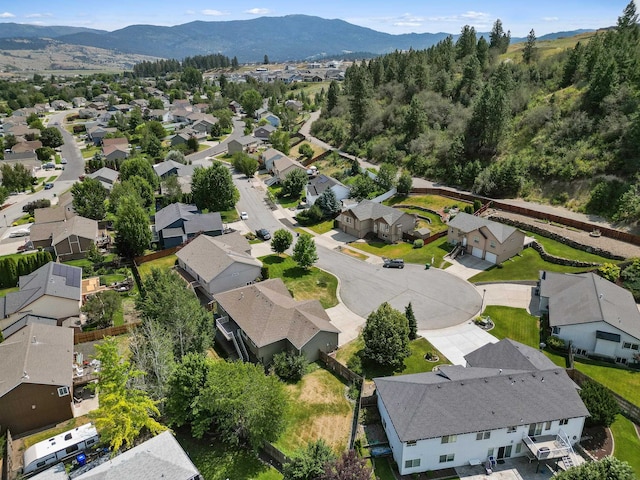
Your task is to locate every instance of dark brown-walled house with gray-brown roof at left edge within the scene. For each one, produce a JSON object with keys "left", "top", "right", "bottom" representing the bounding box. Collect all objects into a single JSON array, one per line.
[{"left": 0, "top": 323, "right": 73, "bottom": 435}]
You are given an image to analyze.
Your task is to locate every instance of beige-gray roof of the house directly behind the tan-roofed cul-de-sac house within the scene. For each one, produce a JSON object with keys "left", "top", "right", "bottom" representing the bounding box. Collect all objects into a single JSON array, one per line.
[{"left": 176, "top": 232, "right": 262, "bottom": 283}]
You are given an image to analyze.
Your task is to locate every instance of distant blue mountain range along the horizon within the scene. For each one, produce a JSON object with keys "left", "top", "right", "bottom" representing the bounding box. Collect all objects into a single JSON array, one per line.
[{"left": 0, "top": 15, "right": 589, "bottom": 62}]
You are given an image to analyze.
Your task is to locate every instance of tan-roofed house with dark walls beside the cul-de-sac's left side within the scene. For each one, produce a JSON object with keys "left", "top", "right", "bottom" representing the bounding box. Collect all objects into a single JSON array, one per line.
[{"left": 215, "top": 278, "right": 339, "bottom": 365}]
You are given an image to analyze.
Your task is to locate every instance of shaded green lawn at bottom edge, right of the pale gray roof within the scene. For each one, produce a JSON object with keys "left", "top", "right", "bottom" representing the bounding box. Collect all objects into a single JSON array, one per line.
[{"left": 176, "top": 433, "right": 282, "bottom": 480}]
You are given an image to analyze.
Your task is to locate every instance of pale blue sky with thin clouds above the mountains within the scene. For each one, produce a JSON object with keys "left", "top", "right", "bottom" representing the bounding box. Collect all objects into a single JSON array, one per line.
[{"left": 0, "top": 0, "right": 628, "bottom": 37}]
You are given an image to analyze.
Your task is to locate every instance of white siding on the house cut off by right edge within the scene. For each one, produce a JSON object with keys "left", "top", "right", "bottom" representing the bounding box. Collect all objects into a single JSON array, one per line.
[{"left": 555, "top": 322, "right": 640, "bottom": 362}]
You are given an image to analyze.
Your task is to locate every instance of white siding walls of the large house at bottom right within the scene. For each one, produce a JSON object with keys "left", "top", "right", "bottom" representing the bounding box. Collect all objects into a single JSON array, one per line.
[{"left": 378, "top": 398, "right": 584, "bottom": 475}]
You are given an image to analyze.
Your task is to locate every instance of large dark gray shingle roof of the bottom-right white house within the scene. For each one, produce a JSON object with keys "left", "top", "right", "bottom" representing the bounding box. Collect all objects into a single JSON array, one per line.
[{"left": 374, "top": 366, "right": 588, "bottom": 442}]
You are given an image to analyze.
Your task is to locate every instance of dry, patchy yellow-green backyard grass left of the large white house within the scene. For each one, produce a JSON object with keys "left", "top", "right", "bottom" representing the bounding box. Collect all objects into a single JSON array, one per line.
[{"left": 276, "top": 366, "right": 354, "bottom": 456}]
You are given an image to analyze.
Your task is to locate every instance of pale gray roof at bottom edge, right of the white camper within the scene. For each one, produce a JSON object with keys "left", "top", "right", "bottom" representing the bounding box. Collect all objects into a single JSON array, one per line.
[{"left": 74, "top": 430, "right": 202, "bottom": 480}]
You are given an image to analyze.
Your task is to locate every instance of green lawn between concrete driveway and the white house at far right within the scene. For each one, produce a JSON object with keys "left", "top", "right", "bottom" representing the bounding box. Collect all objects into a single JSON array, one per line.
[{"left": 484, "top": 305, "right": 540, "bottom": 348}]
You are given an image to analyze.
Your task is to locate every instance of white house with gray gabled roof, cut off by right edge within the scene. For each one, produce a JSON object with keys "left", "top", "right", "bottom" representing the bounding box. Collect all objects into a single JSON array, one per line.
[{"left": 538, "top": 271, "right": 640, "bottom": 364}]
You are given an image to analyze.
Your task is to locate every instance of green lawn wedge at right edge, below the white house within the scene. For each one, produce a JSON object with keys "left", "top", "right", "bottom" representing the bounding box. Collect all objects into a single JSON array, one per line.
[{"left": 574, "top": 358, "right": 640, "bottom": 406}]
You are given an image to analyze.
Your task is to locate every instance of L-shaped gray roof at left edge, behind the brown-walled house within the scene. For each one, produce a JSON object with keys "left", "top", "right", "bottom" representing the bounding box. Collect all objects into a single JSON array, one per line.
[{"left": 2, "top": 262, "right": 82, "bottom": 316}]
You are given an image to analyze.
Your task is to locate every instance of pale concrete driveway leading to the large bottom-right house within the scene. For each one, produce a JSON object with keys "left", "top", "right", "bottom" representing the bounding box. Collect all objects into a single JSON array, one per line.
[{"left": 418, "top": 321, "right": 498, "bottom": 366}]
